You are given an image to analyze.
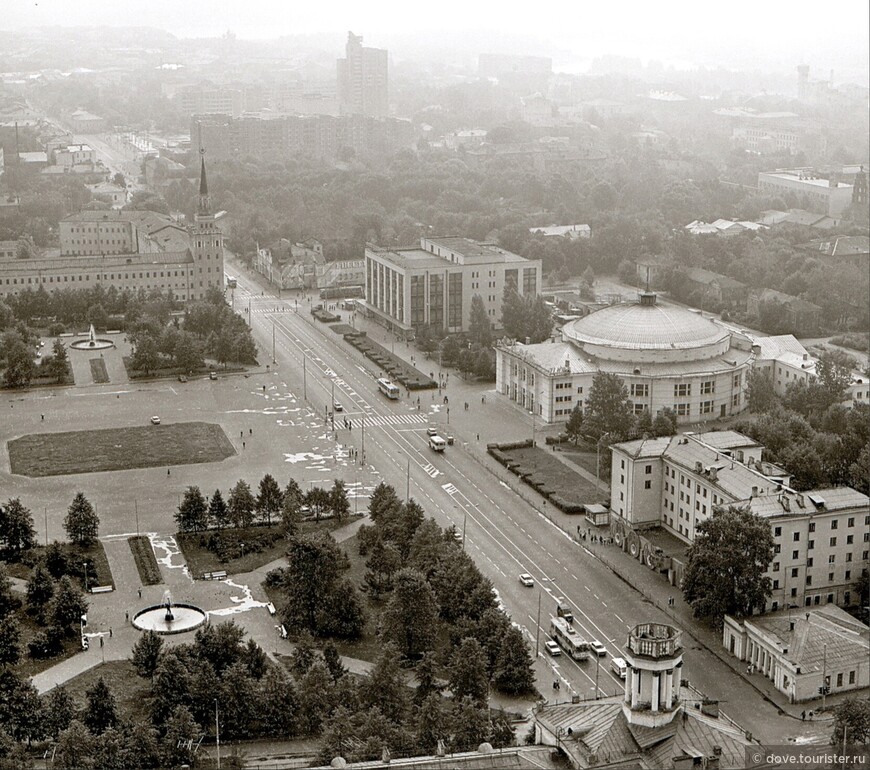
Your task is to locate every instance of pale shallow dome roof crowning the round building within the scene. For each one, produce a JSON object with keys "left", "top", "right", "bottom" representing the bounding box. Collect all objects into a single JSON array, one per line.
[{"left": 562, "top": 301, "right": 729, "bottom": 350}]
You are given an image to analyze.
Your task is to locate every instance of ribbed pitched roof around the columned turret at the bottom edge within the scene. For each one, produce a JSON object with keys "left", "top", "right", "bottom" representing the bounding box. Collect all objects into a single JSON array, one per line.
[{"left": 536, "top": 687, "right": 752, "bottom": 770}]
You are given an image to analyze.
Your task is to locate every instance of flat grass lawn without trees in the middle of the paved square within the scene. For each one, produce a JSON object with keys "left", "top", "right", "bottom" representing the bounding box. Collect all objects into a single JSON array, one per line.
[{"left": 8, "top": 422, "right": 236, "bottom": 476}]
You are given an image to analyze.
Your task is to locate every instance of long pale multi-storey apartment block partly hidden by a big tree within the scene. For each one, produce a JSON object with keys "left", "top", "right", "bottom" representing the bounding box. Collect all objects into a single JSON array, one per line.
[{"left": 610, "top": 431, "right": 870, "bottom": 610}]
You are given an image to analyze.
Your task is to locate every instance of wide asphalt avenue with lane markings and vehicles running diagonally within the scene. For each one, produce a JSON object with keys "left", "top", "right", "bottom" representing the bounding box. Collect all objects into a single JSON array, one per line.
[{"left": 228, "top": 266, "right": 794, "bottom": 740}]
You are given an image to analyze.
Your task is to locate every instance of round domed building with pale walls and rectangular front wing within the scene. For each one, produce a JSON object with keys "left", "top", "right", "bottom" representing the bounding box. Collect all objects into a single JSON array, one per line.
[{"left": 496, "top": 292, "right": 755, "bottom": 423}]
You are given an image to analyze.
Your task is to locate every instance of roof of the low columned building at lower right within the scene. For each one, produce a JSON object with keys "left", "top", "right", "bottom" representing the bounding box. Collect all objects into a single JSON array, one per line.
[{"left": 729, "top": 604, "right": 870, "bottom": 674}]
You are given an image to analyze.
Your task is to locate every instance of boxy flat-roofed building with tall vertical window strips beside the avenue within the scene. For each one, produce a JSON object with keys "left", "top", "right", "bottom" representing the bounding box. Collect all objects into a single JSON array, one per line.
[{"left": 365, "top": 236, "right": 541, "bottom": 335}]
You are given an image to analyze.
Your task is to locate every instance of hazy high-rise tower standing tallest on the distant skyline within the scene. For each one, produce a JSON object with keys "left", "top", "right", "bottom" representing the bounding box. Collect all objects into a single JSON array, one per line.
[{"left": 336, "top": 32, "right": 390, "bottom": 118}]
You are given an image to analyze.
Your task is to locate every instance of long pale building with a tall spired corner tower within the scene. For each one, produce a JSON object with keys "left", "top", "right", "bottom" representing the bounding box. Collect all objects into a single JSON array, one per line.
[{"left": 0, "top": 161, "right": 224, "bottom": 300}]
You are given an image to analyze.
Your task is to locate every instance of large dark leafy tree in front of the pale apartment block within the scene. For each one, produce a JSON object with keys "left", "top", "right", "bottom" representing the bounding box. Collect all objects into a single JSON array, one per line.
[{"left": 682, "top": 506, "right": 773, "bottom": 624}]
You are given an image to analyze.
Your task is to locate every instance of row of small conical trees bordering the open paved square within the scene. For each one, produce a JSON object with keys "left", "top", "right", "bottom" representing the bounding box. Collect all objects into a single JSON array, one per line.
[{"left": 175, "top": 473, "right": 350, "bottom": 534}]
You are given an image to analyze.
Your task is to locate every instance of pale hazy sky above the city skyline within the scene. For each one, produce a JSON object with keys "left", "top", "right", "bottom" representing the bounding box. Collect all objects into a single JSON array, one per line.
[{"left": 0, "top": 0, "right": 870, "bottom": 79}]
